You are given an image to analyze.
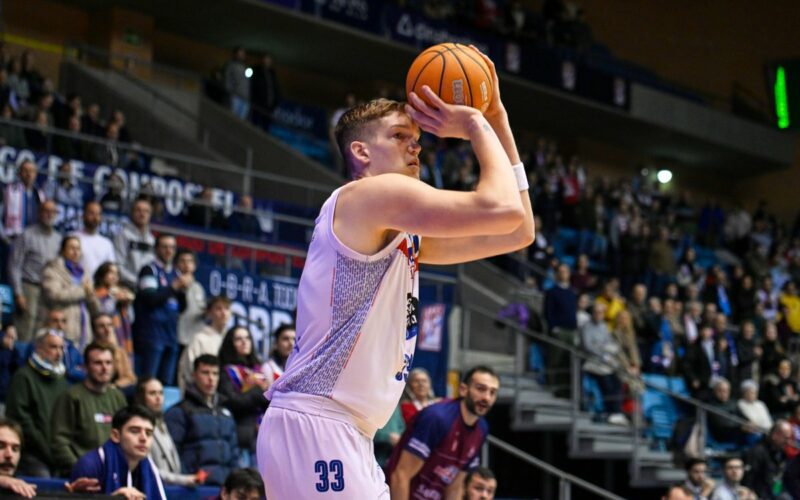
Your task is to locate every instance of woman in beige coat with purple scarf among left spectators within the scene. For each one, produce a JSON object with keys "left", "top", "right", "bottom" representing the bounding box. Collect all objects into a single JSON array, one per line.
[{"left": 39, "top": 236, "right": 100, "bottom": 348}]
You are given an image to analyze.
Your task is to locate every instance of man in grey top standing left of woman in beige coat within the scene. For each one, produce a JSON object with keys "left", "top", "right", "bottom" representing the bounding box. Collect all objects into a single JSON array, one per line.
[{"left": 8, "top": 200, "right": 61, "bottom": 342}]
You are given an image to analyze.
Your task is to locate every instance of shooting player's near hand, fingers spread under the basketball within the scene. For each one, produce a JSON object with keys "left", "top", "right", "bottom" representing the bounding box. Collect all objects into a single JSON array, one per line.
[{"left": 406, "top": 85, "right": 482, "bottom": 139}]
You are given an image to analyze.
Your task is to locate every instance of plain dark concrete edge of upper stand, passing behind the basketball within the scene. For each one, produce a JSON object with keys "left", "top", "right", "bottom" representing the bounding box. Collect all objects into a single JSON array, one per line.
[{"left": 61, "top": 0, "right": 795, "bottom": 176}]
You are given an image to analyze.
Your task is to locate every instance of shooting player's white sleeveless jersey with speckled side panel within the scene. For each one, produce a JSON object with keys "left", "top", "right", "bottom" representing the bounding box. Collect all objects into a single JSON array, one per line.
[{"left": 267, "top": 188, "right": 420, "bottom": 435}]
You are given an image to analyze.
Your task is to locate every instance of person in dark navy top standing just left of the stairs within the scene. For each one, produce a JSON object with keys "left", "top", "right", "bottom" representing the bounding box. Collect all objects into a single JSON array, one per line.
[{"left": 544, "top": 264, "right": 578, "bottom": 391}]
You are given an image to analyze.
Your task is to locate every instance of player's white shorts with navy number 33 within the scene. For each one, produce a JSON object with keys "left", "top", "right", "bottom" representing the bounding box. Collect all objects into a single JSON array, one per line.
[{"left": 258, "top": 406, "right": 389, "bottom": 500}]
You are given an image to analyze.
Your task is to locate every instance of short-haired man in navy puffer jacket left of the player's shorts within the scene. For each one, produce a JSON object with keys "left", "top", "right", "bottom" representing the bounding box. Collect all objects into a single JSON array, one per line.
[{"left": 165, "top": 354, "right": 239, "bottom": 485}]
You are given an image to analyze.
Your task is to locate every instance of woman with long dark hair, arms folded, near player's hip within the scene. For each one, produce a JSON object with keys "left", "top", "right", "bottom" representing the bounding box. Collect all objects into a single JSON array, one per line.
[{"left": 219, "top": 326, "right": 272, "bottom": 467}]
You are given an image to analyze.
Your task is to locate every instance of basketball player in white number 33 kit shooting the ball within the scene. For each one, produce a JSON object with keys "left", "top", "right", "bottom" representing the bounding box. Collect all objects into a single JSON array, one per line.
[{"left": 258, "top": 47, "right": 534, "bottom": 500}]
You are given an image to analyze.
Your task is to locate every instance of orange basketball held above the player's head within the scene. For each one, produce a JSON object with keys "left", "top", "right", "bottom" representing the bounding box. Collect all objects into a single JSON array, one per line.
[{"left": 406, "top": 43, "right": 492, "bottom": 113}]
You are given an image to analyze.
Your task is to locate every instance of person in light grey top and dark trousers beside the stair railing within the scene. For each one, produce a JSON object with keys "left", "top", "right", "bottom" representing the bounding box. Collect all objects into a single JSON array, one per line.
[{"left": 581, "top": 301, "right": 628, "bottom": 425}]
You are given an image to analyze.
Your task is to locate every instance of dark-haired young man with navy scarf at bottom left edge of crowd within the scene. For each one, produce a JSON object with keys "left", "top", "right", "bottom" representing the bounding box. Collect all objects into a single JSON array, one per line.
[{"left": 67, "top": 406, "right": 167, "bottom": 500}]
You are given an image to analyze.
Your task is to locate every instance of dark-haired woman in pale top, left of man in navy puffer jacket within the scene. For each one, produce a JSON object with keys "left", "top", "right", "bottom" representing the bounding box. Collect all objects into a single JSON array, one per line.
[{"left": 134, "top": 377, "right": 202, "bottom": 486}]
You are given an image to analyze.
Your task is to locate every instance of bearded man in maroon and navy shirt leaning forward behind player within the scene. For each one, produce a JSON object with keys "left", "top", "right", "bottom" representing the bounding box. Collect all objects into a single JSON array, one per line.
[{"left": 387, "top": 366, "right": 500, "bottom": 500}]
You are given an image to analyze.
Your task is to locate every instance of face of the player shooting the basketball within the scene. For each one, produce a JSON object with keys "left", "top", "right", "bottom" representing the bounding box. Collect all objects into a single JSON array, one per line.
[{"left": 366, "top": 112, "right": 421, "bottom": 179}]
